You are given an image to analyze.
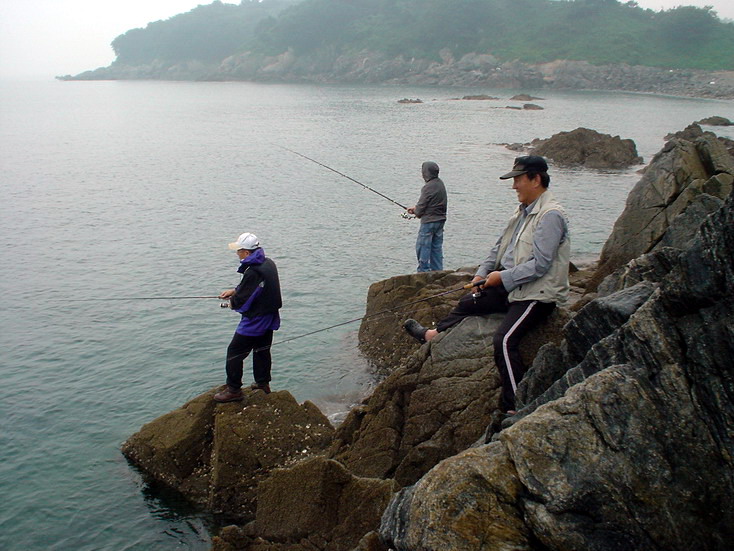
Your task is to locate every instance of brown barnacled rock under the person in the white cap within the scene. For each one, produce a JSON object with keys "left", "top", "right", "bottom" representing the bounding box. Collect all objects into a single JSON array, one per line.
[{"left": 122, "top": 390, "right": 334, "bottom": 519}]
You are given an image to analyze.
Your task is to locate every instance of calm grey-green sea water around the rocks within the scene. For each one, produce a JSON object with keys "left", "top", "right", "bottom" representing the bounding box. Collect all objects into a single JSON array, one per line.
[{"left": 0, "top": 82, "right": 734, "bottom": 551}]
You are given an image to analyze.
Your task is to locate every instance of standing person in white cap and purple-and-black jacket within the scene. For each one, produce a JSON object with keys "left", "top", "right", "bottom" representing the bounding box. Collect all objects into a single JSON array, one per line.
[{"left": 214, "top": 233, "right": 283, "bottom": 402}]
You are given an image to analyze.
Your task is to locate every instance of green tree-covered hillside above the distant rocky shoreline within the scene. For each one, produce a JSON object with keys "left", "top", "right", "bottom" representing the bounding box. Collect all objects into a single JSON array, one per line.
[{"left": 113, "top": 0, "right": 734, "bottom": 70}]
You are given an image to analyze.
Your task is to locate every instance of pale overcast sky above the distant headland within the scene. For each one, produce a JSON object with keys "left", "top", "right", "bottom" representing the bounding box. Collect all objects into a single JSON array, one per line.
[{"left": 0, "top": 0, "right": 734, "bottom": 79}]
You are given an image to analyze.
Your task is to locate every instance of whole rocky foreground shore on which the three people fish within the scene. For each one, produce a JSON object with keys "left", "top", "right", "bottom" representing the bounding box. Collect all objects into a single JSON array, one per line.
[{"left": 123, "top": 125, "right": 734, "bottom": 551}]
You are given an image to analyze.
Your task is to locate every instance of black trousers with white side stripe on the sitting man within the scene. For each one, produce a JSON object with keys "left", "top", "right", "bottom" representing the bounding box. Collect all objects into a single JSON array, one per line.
[{"left": 436, "top": 286, "right": 556, "bottom": 411}]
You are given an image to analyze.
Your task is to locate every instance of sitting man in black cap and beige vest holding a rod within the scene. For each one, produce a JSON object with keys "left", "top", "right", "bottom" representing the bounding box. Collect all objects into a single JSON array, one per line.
[{"left": 405, "top": 155, "right": 571, "bottom": 415}]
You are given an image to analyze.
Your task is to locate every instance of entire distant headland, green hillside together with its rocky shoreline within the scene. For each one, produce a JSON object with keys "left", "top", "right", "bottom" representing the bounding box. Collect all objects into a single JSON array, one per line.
[{"left": 57, "top": 0, "right": 734, "bottom": 99}]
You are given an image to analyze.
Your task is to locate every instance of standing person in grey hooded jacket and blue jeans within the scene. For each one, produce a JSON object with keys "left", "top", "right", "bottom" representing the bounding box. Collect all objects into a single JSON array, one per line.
[{"left": 407, "top": 161, "right": 448, "bottom": 272}]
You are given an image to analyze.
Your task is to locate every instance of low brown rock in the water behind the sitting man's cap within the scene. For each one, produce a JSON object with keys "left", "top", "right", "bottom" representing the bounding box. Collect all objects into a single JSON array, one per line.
[{"left": 530, "top": 128, "right": 642, "bottom": 169}]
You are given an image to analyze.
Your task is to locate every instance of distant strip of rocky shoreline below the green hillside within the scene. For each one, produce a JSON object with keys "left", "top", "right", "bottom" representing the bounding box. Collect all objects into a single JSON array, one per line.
[{"left": 59, "top": 50, "right": 734, "bottom": 99}]
